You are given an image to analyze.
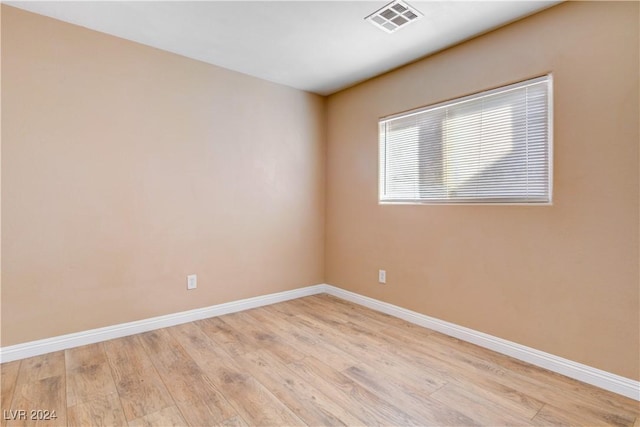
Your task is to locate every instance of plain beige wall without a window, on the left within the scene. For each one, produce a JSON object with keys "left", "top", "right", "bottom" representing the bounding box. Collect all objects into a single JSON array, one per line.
[{"left": 2, "top": 5, "right": 325, "bottom": 346}]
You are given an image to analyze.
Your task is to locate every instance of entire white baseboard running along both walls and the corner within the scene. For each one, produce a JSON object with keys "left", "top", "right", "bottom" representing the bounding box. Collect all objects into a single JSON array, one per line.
[{"left": 0, "top": 284, "right": 640, "bottom": 401}]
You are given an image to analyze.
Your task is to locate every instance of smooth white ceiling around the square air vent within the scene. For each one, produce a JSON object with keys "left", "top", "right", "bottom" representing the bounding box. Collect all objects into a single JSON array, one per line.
[{"left": 4, "top": 0, "right": 559, "bottom": 95}]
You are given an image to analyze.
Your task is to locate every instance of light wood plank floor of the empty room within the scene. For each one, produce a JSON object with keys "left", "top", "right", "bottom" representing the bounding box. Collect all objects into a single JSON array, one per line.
[{"left": 1, "top": 295, "right": 640, "bottom": 427}]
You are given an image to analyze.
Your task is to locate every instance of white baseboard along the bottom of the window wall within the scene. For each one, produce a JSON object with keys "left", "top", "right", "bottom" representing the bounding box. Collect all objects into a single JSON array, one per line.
[{"left": 326, "top": 285, "right": 640, "bottom": 401}]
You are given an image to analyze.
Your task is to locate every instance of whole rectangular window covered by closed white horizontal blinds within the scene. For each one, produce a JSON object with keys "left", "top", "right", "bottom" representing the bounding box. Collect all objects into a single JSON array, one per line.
[{"left": 379, "top": 75, "right": 552, "bottom": 204}]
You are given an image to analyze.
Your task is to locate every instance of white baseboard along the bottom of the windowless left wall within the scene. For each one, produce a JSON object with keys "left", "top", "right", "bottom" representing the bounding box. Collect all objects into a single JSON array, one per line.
[{"left": 0, "top": 285, "right": 326, "bottom": 363}]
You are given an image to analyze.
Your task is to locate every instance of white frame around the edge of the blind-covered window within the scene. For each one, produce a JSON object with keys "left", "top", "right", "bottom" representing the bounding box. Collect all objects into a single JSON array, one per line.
[{"left": 378, "top": 72, "right": 554, "bottom": 206}]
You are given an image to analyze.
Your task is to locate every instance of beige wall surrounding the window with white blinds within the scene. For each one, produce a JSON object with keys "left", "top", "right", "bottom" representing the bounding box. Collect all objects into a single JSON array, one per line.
[{"left": 325, "top": 2, "right": 640, "bottom": 380}]
